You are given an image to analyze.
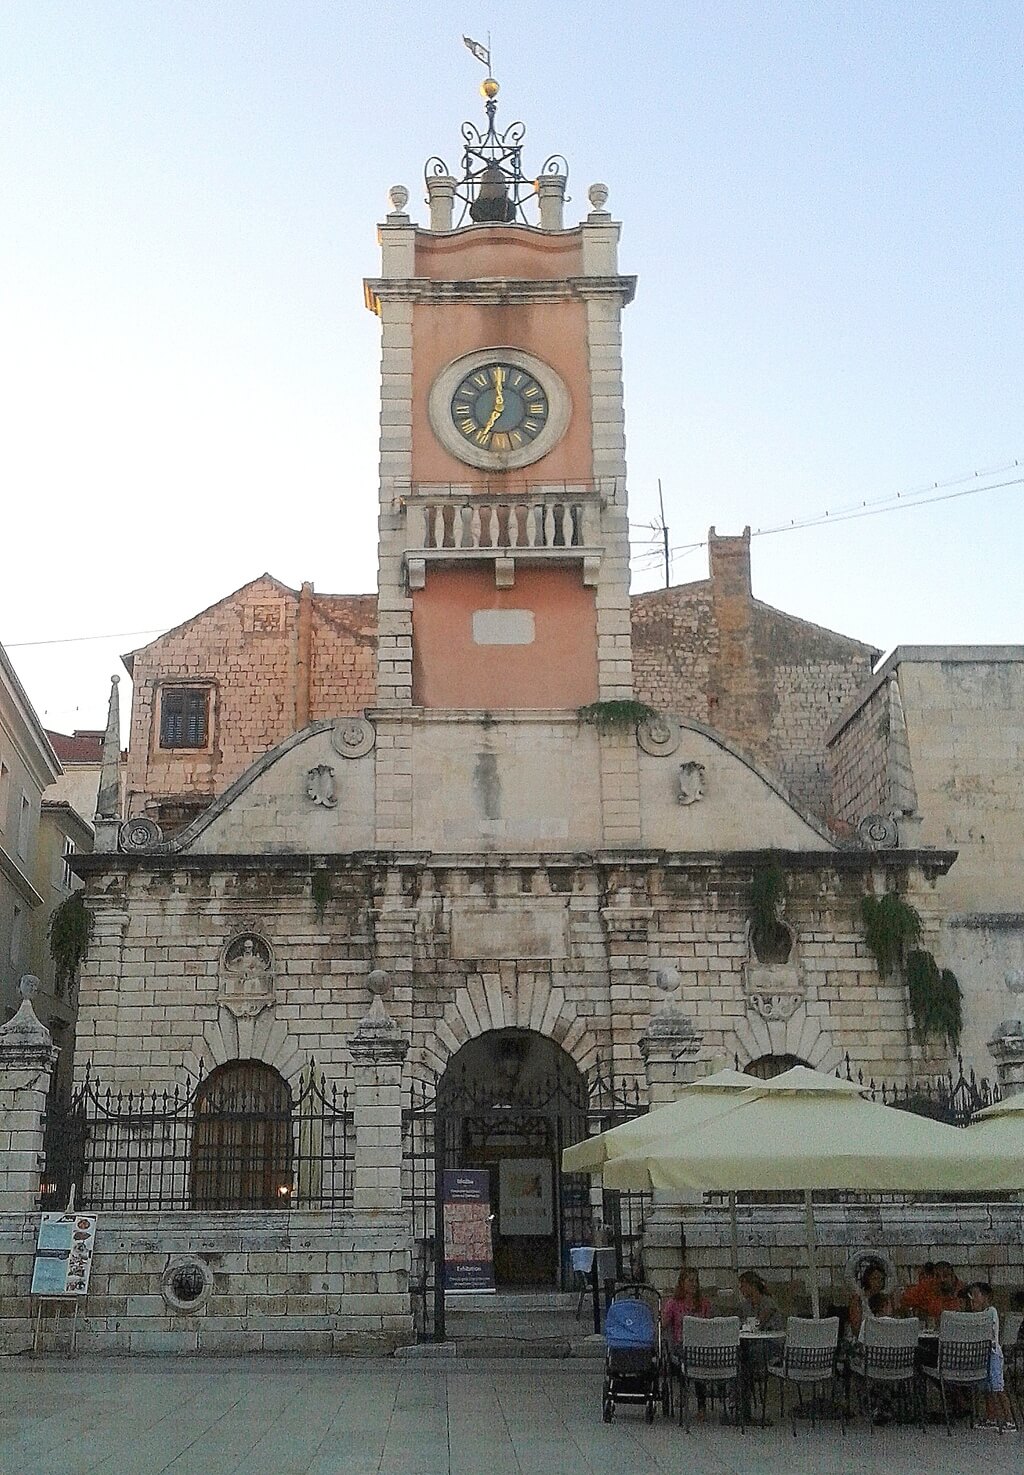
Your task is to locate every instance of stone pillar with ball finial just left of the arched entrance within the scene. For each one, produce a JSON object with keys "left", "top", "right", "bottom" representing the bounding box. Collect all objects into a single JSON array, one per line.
[{"left": 348, "top": 969, "right": 409, "bottom": 1210}]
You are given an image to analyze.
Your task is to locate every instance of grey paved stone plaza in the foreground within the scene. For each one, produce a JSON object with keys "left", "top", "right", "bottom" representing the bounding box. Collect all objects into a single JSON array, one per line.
[{"left": 0, "top": 1358, "right": 1024, "bottom": 1475}]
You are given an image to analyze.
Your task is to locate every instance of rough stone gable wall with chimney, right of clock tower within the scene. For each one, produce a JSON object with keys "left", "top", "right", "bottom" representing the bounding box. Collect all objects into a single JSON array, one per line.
[{"left": 633, "top": 528, "right": 878, "bottom": 817}]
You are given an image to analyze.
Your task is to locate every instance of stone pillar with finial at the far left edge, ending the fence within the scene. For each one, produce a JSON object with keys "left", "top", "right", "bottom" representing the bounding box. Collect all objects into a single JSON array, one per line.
[{"left": 0, "top": 974, "right": 59, "bottom": 1214}]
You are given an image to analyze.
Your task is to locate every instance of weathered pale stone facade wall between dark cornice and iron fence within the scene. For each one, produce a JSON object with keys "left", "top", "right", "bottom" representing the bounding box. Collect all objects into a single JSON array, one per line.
[{"left": 77, "top": 853, "right": 949, "bottom": 1087}]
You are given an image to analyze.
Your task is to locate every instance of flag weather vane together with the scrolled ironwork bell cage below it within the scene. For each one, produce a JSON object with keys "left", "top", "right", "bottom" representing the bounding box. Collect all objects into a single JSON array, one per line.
[{"left": 423, "top": 32, "right": 568, "bottom": 229}]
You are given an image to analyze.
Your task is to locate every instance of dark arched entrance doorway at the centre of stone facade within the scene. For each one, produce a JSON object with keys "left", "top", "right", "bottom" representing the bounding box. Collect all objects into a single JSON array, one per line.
[{"left": 435, "top": 1030, "right": 590, "bottom": 1288}]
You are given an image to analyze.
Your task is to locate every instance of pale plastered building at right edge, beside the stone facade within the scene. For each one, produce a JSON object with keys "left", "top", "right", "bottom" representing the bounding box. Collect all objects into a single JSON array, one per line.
[{"left": 829, "top": 646, "right": 1024, "bottom": 1069}]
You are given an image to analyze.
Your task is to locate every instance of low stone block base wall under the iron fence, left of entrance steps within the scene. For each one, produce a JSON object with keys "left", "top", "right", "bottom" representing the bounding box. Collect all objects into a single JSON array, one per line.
[{"left": 0, "top": 1210, "right": 413, "bottom": 1354}]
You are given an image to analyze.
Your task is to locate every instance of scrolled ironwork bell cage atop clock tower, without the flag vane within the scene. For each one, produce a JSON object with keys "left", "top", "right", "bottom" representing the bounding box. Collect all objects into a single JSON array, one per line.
[{"left": 423, "top": 77, "right": 568, "bottom": 230}]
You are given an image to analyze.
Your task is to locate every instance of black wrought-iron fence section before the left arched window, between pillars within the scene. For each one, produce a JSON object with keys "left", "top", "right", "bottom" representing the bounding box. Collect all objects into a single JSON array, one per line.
[{"left": 41, "top": 1062, "right": 354, "bottom": 1211}]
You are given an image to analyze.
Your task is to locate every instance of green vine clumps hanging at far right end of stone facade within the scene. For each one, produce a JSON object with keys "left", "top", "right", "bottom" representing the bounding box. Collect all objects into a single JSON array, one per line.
[{"left": 860, "top": 891, "right": 964, "bottom": 1049}]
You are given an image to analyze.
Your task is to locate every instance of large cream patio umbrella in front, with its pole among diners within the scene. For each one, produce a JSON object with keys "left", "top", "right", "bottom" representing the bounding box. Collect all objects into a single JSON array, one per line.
[{"left": 603, "top": 1065, "right": 985, "bottom": 1316}]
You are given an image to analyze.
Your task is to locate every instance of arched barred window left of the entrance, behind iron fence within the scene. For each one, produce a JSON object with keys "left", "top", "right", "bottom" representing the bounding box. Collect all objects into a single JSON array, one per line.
[{"left": 190, "top": 1061, "right": 292, "bottom": 1208}]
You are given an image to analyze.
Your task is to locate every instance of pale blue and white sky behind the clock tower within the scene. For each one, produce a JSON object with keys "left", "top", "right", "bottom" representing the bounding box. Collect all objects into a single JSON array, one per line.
[{"left": 0, "top": 0, "right": 1024, "bottom": 730}]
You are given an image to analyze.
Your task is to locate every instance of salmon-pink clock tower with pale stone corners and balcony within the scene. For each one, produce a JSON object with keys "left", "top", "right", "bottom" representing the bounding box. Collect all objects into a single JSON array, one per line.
[{"left": 364, "top": 78, "right": 636, "bottom": 838}]
